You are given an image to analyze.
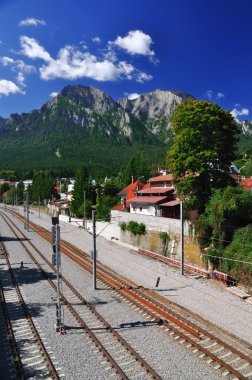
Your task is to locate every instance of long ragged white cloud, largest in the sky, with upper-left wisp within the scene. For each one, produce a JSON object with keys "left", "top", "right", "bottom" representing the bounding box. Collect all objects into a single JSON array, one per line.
[{"left": 20, "top": 36, "right": 152, "bottom": 83}]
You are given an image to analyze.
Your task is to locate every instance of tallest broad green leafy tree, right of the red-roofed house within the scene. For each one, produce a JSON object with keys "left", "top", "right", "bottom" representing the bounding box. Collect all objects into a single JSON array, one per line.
[{"left": 167, "top": 99, "right": 238, "bottom": 213}]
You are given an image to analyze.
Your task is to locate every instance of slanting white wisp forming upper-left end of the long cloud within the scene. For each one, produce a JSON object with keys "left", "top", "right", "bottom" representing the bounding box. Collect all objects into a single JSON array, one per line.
[{"left": 20, "top": 36, "right": 52, "bottom": 62}]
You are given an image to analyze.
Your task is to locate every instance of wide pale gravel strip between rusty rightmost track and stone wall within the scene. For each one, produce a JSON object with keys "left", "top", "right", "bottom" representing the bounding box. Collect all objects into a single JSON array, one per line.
[{"left": 21, "top": 208, "right": 252, "bottom": 344}]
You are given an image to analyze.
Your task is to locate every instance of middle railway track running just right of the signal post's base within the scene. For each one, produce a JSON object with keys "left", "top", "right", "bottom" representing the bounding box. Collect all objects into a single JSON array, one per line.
[{"left": 2, "top": 214, "right": 161, "bottom": 380}]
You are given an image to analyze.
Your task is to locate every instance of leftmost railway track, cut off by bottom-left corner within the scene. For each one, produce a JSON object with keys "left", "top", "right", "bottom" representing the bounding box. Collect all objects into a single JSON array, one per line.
[{"left": 0, "top": 238, "right": 60, "bottom": 379}]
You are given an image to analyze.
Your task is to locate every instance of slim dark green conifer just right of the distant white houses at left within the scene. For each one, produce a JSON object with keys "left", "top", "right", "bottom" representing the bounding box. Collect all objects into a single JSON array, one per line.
[{"left": 71, "top": 165, "right": 89, "bottom": 216}]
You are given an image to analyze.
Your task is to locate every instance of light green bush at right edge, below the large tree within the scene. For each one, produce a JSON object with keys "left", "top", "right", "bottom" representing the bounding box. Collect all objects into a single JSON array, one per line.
[{"left": 221, "top": 224, "right": 252, "bottom": 276}]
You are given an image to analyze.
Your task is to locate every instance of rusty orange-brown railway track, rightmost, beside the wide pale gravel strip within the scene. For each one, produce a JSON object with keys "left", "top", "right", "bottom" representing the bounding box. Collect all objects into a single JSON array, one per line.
[{"left": 1, "top": 209, "right": 252, "bottom": 380}]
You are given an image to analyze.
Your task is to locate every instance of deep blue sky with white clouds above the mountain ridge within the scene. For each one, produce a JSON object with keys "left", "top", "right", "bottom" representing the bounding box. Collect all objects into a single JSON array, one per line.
[{"left": 0, "top": 0, "right": 252, "bottom": 119}]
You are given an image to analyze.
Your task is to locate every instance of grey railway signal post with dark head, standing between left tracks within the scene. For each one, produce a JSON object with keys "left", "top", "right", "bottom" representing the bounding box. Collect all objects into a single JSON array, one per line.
[{"left": 52, "top": 217, "right": 65, "bottom": 334}]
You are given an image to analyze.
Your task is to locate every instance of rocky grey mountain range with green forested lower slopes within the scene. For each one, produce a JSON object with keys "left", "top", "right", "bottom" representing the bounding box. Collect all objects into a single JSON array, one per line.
[{"left": 0, "top": 85, "right": 252, "bottom": 176}]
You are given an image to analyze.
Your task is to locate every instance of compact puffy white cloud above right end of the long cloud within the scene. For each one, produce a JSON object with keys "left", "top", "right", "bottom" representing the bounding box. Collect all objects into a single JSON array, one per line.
[{"left": 112, "top": 30, "right": 155, "bottom": 57}]
